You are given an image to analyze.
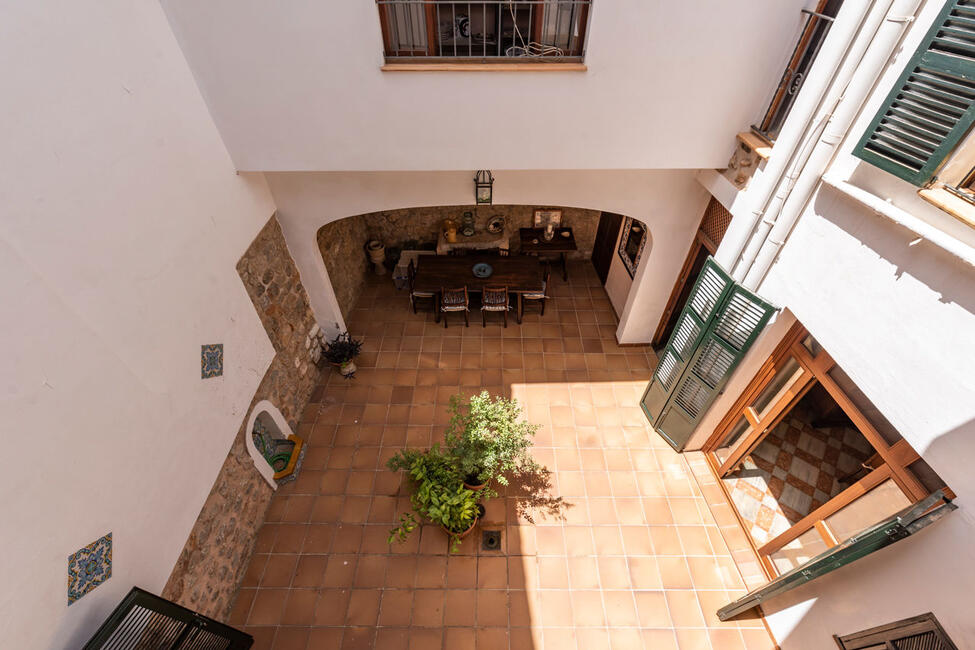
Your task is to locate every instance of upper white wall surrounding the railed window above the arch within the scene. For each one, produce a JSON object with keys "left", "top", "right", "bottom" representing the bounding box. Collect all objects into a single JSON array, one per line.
[{"left": 162, "top": 0, "right": 814, "bottom": 171}]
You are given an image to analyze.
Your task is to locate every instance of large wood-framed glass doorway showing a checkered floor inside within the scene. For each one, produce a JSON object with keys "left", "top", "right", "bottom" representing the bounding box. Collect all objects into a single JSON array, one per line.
[{"left": 703, "top": 323, "right": 954, "bottom": 579}]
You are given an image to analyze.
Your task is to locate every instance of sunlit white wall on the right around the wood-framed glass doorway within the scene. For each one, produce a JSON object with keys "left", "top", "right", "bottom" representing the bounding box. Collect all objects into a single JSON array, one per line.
[{"left": 695, "top": 0, "right": 975, "bottom": 650}]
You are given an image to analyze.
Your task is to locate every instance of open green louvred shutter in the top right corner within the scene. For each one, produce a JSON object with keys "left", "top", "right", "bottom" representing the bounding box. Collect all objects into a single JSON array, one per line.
[{"left": 853, "top": 0, "right": 975, "bottom": 186}]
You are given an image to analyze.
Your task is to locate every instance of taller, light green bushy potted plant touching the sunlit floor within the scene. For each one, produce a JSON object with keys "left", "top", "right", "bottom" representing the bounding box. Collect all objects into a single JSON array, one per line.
[{"left": 445, "top": 391, "right": 538, "bottom": 496}]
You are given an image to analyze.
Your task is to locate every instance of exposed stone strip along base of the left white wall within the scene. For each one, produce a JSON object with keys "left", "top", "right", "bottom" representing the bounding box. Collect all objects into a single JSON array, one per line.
[{"left": 163, "top": 217, "right": 319, "bottom": 620}]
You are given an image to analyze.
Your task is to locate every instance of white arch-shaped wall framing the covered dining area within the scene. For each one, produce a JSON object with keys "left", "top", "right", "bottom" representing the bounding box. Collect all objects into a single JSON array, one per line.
[{"left": 265, "top": 170, "right": 708, "bottom": 343}]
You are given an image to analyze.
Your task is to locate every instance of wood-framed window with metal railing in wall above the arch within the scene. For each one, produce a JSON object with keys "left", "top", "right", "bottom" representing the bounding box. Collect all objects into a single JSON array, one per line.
[{"left": 376, "top": 0, "right": 592, "bottom": 63}]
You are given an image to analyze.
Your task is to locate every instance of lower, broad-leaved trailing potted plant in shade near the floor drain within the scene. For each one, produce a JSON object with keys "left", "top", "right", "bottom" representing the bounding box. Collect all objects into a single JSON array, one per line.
[{"left": 386, "top": 445, "right": 483, "bottom": 552}]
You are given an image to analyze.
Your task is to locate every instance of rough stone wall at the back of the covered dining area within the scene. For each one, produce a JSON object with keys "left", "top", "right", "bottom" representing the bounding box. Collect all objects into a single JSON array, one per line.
[{"left": 318, "top": 205, "right": 600, "bottom": 316}]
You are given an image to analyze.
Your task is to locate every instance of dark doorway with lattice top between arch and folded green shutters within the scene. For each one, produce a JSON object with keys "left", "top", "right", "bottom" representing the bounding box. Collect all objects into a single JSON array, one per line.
[{"left": 656, "top": 197, "right": 731, "bottom": 348}]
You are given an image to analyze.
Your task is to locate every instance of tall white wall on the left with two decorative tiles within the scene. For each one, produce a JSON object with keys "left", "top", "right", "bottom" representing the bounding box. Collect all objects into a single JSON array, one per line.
[{"left": 0, "top": 0, "right": 274, "bottom": 649}]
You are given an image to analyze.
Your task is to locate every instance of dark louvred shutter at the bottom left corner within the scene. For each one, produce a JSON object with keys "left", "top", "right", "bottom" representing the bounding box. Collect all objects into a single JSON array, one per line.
[{"left": 84, "top": 587, "right": 254, "bottom": 650}]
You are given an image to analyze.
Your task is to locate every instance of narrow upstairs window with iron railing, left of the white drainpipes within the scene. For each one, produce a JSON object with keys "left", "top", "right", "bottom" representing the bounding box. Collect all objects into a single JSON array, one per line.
[{"left": 752, "top": 0, "right": 843, "bottom": 143}]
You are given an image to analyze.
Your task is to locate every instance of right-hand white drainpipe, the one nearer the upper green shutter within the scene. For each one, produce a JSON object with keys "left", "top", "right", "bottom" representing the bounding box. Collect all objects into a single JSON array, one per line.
[{"left": 744, "top": 0, "right": 921, "bottom": 289}]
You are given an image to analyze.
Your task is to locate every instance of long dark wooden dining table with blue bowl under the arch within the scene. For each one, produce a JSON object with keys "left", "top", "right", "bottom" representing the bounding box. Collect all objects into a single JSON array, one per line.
[{"left": 413, "top": 254, "right": 545, "bottom": 323}]
